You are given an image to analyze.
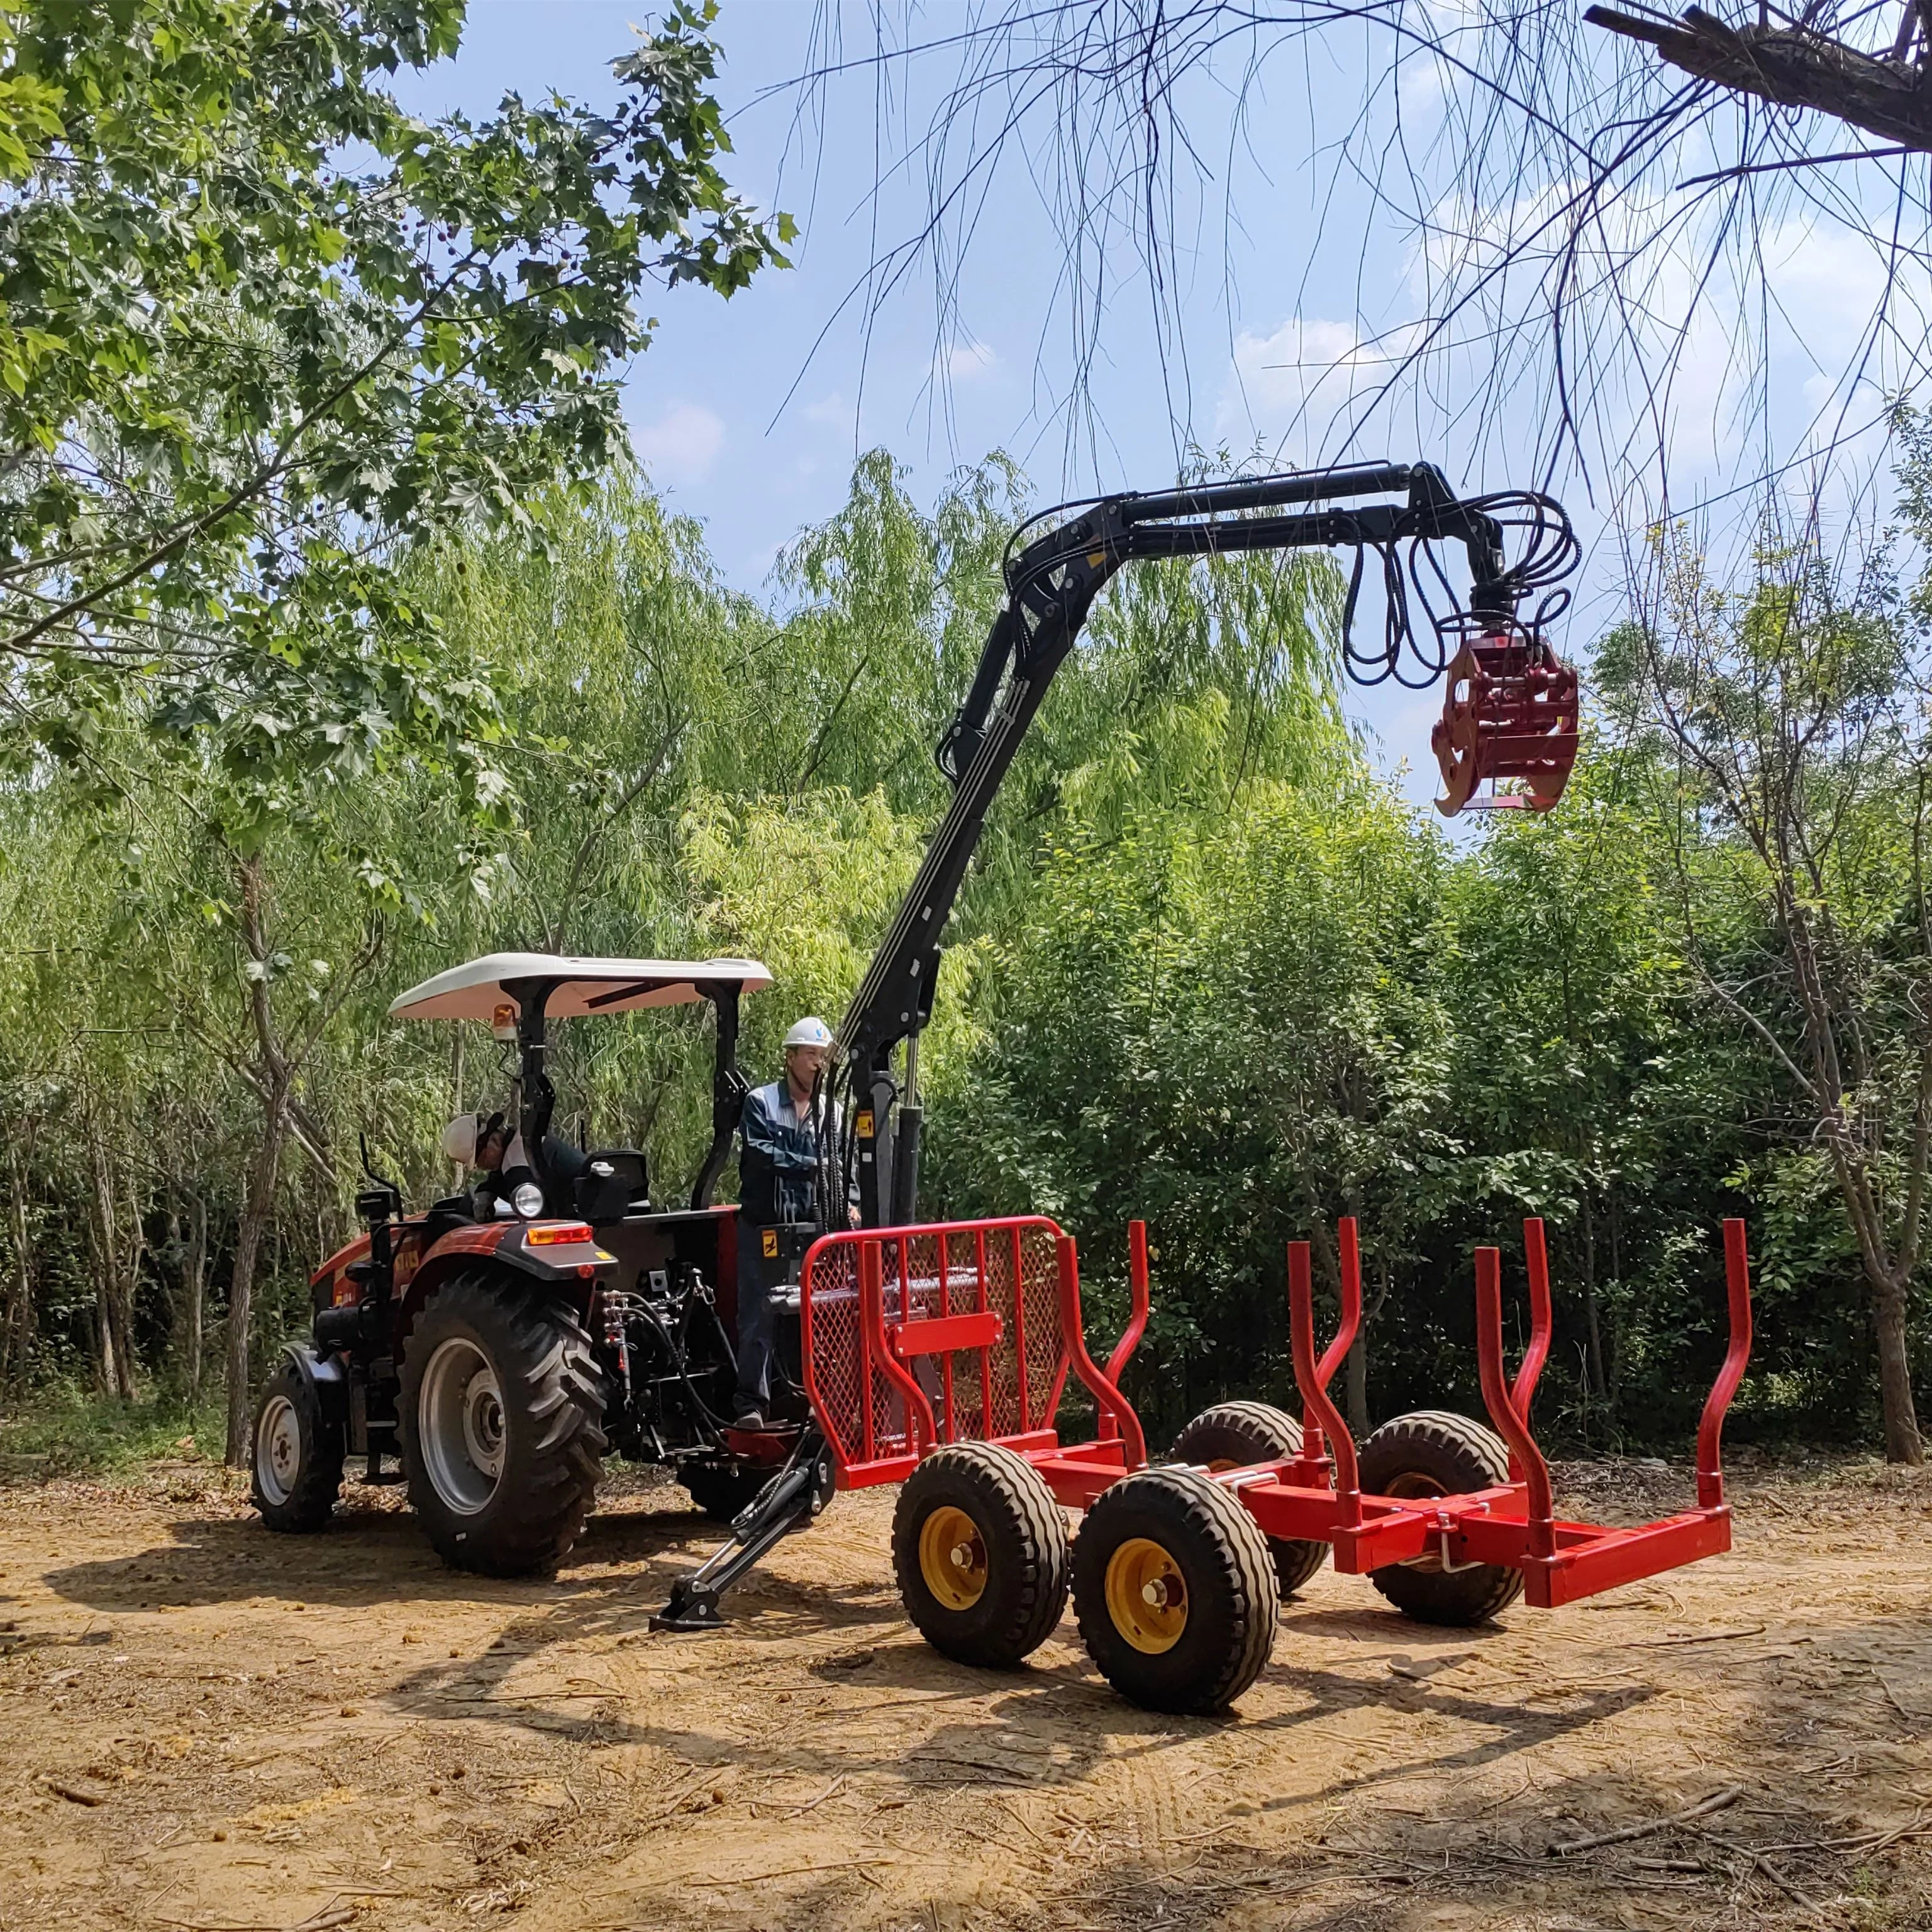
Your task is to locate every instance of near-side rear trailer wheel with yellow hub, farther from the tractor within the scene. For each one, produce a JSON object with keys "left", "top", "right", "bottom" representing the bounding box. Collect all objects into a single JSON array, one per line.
[{"left": 1074, "top": 1468, "right": 1281, "bottom": 1714}]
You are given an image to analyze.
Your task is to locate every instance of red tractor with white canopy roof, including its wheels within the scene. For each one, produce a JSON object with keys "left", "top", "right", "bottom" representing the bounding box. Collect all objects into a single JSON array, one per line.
[{"left": 253, "top": 952, "right": 831, "bottom": 1575}]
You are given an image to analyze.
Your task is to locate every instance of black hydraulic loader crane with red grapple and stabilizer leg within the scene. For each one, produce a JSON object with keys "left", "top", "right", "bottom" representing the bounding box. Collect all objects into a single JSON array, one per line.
[{"left": 661, "top": 462, "right": 1579, "bottom": 1629}]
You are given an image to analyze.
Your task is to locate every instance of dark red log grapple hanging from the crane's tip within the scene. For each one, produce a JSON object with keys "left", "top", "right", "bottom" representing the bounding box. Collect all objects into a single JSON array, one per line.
[{"left": 1430, "top": 620, "right": 1580, "bottom": 819}]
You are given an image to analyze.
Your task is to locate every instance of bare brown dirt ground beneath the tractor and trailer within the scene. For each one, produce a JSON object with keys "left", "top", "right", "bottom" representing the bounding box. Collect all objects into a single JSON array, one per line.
[{"left": 0, "top": 1465, "right": 1932, "bottom": 1932}]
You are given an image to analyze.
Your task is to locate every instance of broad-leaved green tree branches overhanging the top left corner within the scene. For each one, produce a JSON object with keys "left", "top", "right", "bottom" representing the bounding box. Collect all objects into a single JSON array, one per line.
[{"left": 0, "top": 0, "right": 790, "bottom": 680}]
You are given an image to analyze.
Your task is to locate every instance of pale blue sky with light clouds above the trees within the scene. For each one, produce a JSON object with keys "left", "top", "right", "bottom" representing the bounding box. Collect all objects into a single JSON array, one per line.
[{"left": 402, "top": 0, "right": 1916, "bottom": 806}]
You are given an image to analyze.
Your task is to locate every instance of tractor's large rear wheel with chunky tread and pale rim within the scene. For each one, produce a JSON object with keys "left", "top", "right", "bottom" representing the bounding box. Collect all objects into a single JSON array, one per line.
[{"left": 400, "top": 1273, "right": 605, "bottom": 1577}]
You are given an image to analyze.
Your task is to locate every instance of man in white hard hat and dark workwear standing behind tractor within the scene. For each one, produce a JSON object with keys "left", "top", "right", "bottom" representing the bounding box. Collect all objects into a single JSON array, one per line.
[{"left": 734, "top": 1020, "right": 838, "bottom": 1430}]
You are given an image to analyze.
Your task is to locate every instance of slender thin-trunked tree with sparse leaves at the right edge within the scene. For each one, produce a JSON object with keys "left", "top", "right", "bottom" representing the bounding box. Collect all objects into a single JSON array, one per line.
[{"left": 1604, "top": 475, "right": 1932, "bottom": 1463}]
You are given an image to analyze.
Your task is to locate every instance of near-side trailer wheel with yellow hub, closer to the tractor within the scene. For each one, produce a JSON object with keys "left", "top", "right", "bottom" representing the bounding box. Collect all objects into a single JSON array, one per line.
[{"left": 892, "top": 1443, "right": 1067, "bottom": 1669}]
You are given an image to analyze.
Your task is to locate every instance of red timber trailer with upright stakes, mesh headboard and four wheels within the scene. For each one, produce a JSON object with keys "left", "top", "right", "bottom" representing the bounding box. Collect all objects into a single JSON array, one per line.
[{"left": 800, "top": 1215, "right": 1750, "bottom": 1712}]
